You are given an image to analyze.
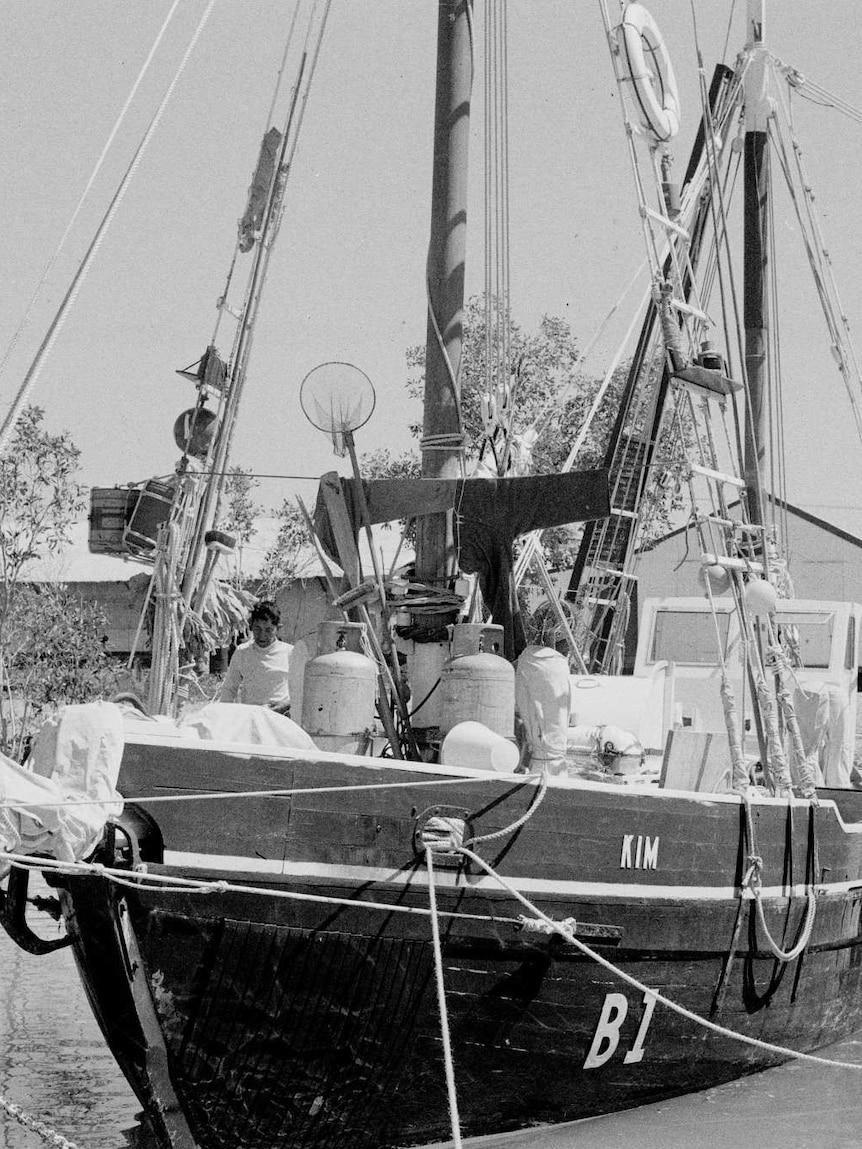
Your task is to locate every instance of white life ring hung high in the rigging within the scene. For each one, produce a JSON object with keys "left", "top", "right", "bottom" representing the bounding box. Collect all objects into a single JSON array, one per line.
[{"left": 617, "top": 3, "right": 679, "bottom": 144}]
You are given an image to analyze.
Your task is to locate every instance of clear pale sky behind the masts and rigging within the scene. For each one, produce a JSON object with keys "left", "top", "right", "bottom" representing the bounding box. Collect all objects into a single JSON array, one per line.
[{"left": 0, "top": 0, "right": 862, "bottom": 553}]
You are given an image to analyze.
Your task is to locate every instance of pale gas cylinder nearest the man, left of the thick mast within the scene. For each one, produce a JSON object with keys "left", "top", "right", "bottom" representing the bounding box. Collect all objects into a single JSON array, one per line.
[{"left": 302, "top": 620, "right": 377, "bottom": 754}]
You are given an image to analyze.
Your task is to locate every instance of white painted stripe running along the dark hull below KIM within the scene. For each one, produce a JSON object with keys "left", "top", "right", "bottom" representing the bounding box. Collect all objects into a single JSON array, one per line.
[{"left": 158, "top": 850, "right": 862, "bottom": 902}]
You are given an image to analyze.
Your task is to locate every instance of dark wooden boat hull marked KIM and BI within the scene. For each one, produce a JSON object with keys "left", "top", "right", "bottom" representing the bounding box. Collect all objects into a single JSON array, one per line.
[{"left": 48, "top": 748, "right": 862, "bottom": 1149}]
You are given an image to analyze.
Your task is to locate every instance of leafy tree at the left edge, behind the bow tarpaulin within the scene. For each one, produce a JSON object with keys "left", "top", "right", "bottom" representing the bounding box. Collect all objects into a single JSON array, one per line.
[{"left": 0, "top": 407, "right": 113, "bottom": 747}]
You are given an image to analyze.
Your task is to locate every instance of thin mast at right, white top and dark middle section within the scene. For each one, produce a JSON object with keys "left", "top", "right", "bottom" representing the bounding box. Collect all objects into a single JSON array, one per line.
[{"left": 742, "top": 0, "right": 770, "bottom": 525}]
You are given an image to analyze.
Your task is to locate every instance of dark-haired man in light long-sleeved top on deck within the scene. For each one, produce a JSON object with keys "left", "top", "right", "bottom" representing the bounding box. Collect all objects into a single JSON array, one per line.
[{"left": 216, "top": 601, "right": 293, "bottom": 715}]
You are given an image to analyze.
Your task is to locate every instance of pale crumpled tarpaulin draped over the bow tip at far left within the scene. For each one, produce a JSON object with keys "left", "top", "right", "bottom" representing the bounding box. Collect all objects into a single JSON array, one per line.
[{"left": 0, "top": 702, "right": 124, "bottom": 862}]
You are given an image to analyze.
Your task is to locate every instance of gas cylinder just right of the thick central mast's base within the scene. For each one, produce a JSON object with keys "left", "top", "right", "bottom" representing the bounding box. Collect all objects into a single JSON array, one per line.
[{"left": 440, "top": 623, "right": 515, "bottom": 738}]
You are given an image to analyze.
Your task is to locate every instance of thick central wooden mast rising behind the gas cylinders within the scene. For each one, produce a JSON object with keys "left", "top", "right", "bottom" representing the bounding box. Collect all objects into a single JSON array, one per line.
[{"left": 416, "top": 0, "right": 472, "bottom": 583}]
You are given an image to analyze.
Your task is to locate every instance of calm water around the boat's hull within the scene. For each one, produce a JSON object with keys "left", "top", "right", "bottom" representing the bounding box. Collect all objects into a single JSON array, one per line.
[{"left": 0, "top": 910, "right": 862, "bottom": 1149}]
